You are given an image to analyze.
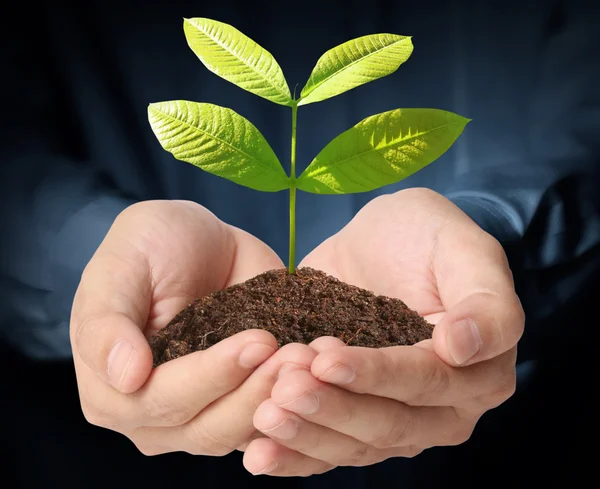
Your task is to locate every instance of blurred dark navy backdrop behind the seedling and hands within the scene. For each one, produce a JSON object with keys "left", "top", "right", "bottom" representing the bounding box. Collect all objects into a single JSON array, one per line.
[{"left": 0, "top": 0, "right": 600, "bottom": 487}]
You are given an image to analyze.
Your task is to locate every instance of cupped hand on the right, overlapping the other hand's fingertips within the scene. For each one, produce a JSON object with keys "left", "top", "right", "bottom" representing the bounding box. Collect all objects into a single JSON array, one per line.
[{"left": 244, "top": 189, "right": 524, "bottom": 475}]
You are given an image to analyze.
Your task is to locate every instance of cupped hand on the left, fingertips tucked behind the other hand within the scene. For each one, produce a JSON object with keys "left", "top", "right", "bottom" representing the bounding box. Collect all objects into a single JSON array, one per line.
[{"left": 71, "top": 201, "right": 316, "bottom": 455}]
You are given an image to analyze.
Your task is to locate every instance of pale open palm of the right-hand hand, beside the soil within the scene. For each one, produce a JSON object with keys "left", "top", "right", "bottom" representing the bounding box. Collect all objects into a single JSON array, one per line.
[{"left": 301, "top": 190, "right": 466, "bottom": 324}]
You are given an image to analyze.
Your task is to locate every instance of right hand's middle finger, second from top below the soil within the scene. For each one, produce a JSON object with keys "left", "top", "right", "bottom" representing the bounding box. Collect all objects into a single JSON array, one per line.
[{"left": 271, "top": 371, "right": 464, "bottom": 449}]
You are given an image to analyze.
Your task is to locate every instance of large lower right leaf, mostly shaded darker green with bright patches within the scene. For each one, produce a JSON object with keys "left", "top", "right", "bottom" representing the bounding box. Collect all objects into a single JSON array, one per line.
[{"left": 297, "top": 109, "right": 470, "bottom": 194}]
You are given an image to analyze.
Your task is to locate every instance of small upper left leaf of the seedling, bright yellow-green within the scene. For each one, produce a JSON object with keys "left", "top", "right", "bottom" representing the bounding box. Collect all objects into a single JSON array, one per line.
[{"left": 183, "top": 18, "right": 292, "bottom": 105}]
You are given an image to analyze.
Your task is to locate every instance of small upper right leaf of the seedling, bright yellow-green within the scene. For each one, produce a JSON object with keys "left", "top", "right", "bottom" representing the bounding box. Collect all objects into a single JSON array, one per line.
[{"left": 298, "top": 34, "right": 413, "bottom": 105}]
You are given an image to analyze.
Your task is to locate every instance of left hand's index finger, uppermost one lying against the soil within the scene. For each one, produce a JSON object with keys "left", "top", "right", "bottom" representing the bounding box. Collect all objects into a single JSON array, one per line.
[{"left": 133, "top": 329, "right": 277, "bottom": 426}]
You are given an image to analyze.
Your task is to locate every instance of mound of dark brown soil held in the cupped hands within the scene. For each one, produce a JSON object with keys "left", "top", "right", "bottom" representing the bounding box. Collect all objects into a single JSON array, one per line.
[{"left": 150, "top": 267, "right": 433, "bottom": 367}]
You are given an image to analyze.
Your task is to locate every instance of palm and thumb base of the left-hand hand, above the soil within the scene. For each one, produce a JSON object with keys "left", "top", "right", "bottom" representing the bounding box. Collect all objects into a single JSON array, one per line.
[{"left": 115, "top": 201, "right": 283, "bottom": 336}]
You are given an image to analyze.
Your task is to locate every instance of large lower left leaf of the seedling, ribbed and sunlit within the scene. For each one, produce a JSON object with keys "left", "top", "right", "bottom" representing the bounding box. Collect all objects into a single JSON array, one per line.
[{"left": 148, "top": 100, "right": 289, "bottom": 192}]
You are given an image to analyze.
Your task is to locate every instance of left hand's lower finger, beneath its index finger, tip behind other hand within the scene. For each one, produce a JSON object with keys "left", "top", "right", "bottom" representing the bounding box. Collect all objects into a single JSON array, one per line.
[{"left": 135, "top": 343, "right": 316, "bottom": 456}]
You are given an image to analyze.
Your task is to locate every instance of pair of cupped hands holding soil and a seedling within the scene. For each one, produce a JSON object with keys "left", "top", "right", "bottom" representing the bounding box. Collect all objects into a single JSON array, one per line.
[{"left": 71, "top": 189, "right": 524, "bottom": 476}]
